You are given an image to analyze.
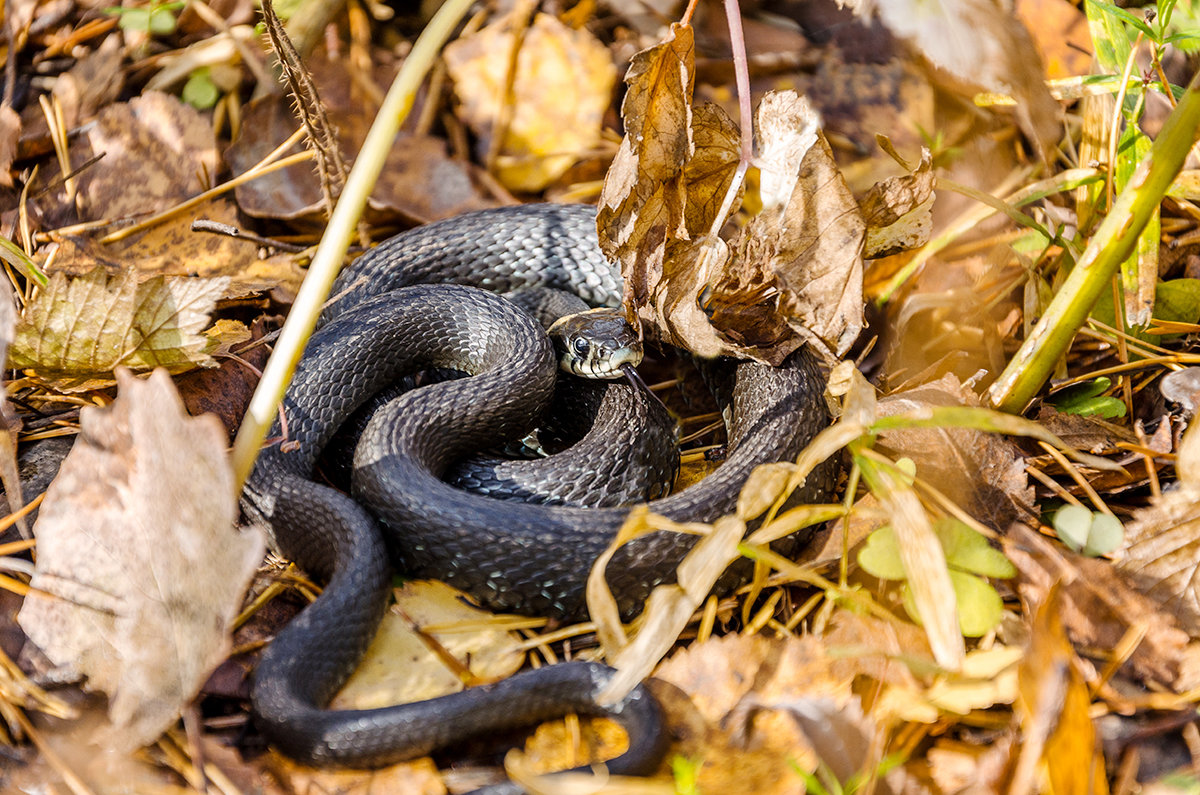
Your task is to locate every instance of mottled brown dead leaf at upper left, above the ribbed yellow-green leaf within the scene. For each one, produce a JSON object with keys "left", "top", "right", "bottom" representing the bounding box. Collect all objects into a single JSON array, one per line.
[{"left": 72, "top": 91, "right": 220, "bottom": 221}]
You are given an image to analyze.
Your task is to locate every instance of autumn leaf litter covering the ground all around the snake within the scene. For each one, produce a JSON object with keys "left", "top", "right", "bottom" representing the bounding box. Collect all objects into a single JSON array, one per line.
[{"left": 0, "top": 0, "right": 1200, "bottom": 793}]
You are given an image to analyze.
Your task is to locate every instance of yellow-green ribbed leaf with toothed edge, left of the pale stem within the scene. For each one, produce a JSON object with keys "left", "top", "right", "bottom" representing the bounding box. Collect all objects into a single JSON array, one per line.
[{"left": 8, "top": 268, "right": 238, "bottom": 391}]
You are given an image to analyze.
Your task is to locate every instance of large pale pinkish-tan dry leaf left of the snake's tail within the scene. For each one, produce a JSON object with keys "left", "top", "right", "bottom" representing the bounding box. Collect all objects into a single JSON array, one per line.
[{"left": 18, "top": 370, "right": 265, "bottom": 751}]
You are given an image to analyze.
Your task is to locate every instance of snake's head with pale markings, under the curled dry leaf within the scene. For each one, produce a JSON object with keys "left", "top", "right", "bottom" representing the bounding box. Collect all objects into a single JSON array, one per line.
[{"left": 547, "top": 309, "right": 642, "bottom": 378}]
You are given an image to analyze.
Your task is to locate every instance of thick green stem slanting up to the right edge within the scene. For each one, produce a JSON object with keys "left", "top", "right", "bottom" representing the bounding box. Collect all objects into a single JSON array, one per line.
[{"left": 988, "top": 72, "right": 1200, "bottom": 413}]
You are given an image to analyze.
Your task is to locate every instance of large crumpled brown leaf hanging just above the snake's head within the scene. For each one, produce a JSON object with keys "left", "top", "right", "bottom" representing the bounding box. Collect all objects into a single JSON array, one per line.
[{"left": 598, "top": 25, "right": 865, "bottom": 364}]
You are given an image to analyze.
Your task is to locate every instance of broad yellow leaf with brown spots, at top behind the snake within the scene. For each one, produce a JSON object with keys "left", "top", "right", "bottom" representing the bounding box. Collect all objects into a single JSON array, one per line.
[{"left": 444, "top": 12, "right": 617, "bottom": 193}]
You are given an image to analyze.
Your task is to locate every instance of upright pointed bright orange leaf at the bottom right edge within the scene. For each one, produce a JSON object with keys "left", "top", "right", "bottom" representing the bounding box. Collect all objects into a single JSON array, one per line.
[{"left": 1008, "top": 587, "right": 1108, "bottom": 795}]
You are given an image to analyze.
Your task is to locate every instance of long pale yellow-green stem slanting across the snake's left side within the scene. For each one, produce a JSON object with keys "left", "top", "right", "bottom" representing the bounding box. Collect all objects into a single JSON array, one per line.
[{"left": 233, "top": 0, "right": 472, "bottom": 494}]
